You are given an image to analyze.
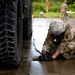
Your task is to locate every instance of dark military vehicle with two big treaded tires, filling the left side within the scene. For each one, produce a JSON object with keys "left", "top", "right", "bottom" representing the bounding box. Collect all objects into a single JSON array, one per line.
[{"left": 0, "top": 0, "right": 32, "bottom": 66}]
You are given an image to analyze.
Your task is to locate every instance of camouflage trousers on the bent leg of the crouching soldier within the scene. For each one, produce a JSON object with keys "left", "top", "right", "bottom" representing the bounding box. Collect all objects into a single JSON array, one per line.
[{"left": 62, "top": 42, "right": 75, "bottom": 59}]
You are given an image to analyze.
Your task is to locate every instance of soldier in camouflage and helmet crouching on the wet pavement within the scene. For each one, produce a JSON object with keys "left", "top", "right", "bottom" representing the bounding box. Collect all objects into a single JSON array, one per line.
[{"left": 33, "top": 21, "right": 75, "bottom": 61}]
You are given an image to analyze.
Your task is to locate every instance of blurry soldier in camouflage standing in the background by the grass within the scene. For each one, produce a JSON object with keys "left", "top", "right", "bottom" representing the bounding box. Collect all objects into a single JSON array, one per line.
[{"left": 60, "top": 0, "right": 68, "bottom": 22}]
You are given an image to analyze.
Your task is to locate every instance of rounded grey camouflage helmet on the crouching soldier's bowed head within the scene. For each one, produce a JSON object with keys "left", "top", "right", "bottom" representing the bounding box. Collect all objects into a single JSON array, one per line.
[{"left": 49, "top": 21, "right": 66, "bottom": 36}]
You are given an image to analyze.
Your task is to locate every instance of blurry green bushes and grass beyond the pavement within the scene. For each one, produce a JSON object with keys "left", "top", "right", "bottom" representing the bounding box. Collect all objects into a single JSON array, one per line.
[{"left": 32, "top": 0, "right": 75, "bottom": 18}]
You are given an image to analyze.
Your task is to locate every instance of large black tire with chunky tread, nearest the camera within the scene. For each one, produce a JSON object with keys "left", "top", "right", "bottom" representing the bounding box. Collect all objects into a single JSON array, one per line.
[{"left": 0, "top": 0, "right": 23, "bottom": 66}]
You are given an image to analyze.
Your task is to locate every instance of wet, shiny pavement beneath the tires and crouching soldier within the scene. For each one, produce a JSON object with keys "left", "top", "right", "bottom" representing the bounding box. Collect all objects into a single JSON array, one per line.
[{"left": 0, "top": 18, "right": 75, "bottom": 75}]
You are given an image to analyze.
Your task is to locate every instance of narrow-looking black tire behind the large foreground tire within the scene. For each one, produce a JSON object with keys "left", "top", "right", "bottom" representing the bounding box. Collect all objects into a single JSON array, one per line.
[{"left": 23, "top": 0, "right": 32, "bottom": 40}]
